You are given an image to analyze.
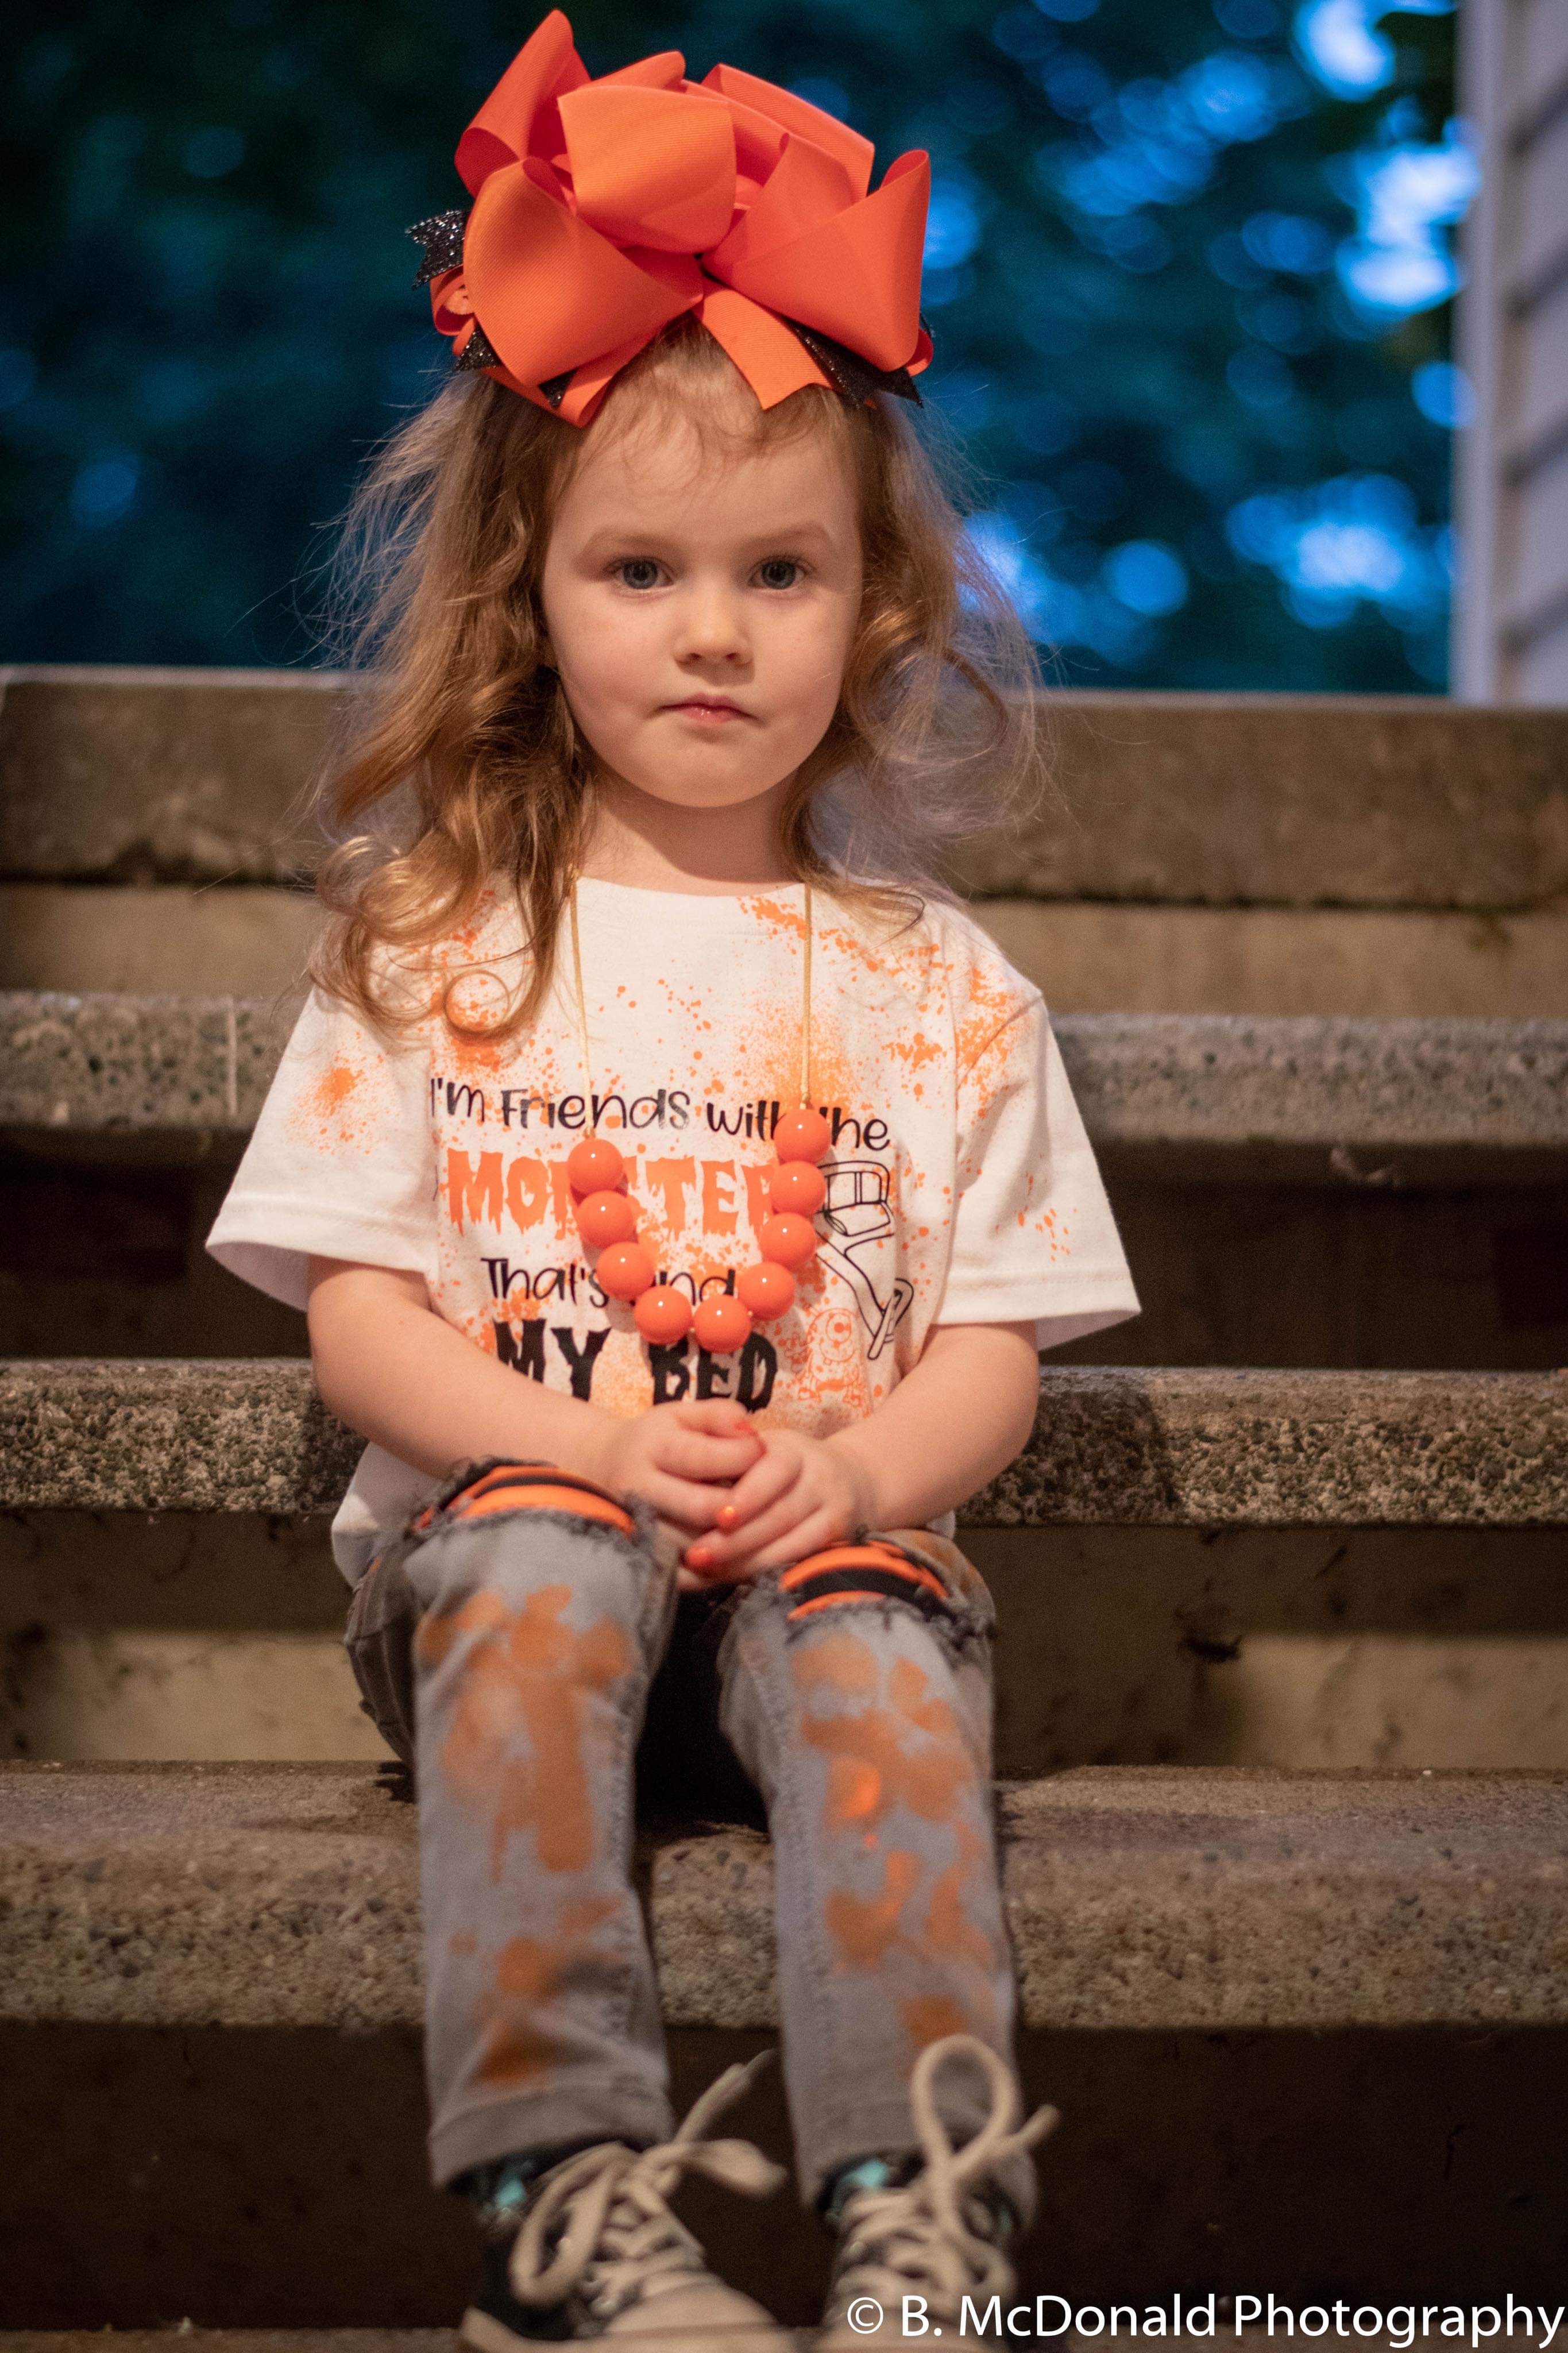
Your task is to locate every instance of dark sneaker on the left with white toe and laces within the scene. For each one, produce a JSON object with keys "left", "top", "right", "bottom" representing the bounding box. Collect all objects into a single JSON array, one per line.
[{"left": 461, "top": 2052, "right": 792, "bottom": 2353}]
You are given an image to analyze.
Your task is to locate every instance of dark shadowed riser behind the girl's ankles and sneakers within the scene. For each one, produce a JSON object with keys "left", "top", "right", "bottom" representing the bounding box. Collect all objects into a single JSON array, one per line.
[{"left": 0, "top": 2026, "right": 1568, "bottom": 2329}]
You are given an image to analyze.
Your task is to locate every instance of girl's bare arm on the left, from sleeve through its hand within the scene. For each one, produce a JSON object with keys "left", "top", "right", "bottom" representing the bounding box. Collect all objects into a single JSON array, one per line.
[{"left": 308, "top": 1259, "right": 757, "bottom": 1527}]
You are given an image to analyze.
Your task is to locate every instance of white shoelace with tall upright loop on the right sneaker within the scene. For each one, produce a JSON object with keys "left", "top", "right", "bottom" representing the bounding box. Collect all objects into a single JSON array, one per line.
[{"left": 828, "top": 2035, "right": 1060, "bottom": 2327}]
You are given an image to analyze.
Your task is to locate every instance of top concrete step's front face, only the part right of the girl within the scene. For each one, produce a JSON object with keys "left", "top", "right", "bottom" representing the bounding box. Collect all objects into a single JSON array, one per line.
[{"left": 945, "top": 694, "right": 1568, "bottom": 911}]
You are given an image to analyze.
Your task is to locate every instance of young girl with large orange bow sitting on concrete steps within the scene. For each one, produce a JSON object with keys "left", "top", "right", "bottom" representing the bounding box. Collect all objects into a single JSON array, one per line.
[{"left": 211, "top": 14, "right": 1136, "bottom": 2353}]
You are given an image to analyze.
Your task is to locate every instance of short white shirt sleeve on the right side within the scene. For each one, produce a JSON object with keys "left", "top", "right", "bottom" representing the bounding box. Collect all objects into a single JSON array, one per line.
[{"left": 936, "top": 990, "right": 1138, "bottom": 1348}]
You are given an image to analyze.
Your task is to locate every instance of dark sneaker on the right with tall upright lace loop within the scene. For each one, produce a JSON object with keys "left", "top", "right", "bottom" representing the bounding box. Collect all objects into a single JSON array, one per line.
[{"left": 816, "top": 2035, "right": 1060, "bottom": 2353}]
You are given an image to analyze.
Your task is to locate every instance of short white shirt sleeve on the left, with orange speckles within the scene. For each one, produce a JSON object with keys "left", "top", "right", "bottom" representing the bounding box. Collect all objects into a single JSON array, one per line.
[{"left": 207, "top": 988, "right": 435, "bottom": 1308}]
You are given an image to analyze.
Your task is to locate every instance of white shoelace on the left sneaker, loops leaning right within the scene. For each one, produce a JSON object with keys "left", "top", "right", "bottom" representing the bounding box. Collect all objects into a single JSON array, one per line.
[{"left": 510, "top": 2052, "right": 785, "bottom": 2318}]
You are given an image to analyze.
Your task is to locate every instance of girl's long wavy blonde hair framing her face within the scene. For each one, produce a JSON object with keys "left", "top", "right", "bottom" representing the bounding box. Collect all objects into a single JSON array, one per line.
[{"left": 310, "top": 320, "right": 1039, "bottom": 1037}]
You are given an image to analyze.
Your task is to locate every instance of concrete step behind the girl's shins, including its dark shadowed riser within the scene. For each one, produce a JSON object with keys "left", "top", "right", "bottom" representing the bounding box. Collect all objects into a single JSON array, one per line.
[{"left": 0, "top": 1767, "right": 1568, "bottom": 2324}]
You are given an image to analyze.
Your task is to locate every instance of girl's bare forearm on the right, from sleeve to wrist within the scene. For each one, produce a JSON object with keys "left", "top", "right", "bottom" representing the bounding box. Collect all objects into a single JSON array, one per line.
[{"left": 828, "top": 1320, "right": 1039, "bottom": 1527}]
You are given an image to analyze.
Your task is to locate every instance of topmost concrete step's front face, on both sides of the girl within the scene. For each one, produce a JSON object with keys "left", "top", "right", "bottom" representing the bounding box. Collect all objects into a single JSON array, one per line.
[{"left": 0, "top": 668, "right": 1568, "bottom": 911}]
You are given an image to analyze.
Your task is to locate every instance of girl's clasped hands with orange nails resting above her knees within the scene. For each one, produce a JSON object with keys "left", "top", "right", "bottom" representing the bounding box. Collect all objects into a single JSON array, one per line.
[{"left": 585, "top": 1398, "right": 875, "bottom": 1593}]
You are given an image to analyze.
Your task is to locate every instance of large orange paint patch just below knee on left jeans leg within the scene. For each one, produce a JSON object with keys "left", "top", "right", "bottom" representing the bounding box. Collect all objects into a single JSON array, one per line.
[{"left": 416, "top": 1586, "right": 632, "bottom": 1880}]
